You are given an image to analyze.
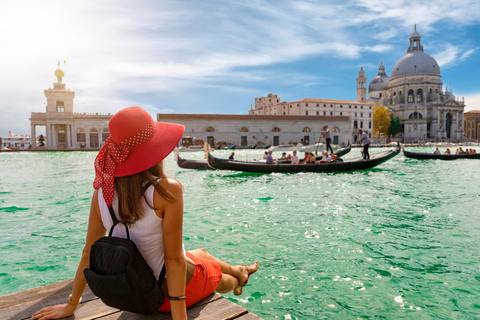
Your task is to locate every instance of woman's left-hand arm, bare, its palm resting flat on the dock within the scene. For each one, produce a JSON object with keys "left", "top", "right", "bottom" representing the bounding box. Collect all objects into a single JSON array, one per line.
[{"left": 32, "top": 190, "right": 106, "bottom": 320}]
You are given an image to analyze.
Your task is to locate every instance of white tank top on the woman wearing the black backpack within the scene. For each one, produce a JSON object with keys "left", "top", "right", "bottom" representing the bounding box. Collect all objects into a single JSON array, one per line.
[{"left": 98, "top": 181, "right": 185, "bottom": 280}]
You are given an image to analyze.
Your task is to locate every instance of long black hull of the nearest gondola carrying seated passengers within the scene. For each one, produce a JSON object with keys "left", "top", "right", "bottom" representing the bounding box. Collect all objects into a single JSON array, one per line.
[{"left": 207, "top": 144, "right": 401, "bottom": 173}]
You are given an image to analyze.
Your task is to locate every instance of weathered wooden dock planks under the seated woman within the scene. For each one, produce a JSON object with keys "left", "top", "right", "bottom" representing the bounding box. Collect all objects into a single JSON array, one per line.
[{"left": 0, "top": 279, "right": 261, "bottom": 320}]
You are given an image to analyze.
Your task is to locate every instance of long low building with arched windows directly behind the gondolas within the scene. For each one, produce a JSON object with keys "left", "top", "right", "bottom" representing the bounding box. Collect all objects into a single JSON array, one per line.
[{"left": 157, "top": 113, "right": 351, "bottom": 148}]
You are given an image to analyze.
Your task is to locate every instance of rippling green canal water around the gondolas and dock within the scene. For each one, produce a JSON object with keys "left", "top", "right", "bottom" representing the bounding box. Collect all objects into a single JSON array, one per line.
[{"left": 0, "top": 148, "right": 480, "bottom": 319}]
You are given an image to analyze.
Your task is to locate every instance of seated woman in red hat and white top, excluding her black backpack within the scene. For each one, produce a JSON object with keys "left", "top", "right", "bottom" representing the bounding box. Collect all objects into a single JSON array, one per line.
[{"left": 32, "top": 107, "right": 258, "bottom": 320}]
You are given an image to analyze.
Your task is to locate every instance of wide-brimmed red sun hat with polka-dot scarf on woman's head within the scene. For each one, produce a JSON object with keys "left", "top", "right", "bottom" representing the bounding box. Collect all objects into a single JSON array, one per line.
[{"left": 93, "top": 107, "right": 185, "bottom": 205}]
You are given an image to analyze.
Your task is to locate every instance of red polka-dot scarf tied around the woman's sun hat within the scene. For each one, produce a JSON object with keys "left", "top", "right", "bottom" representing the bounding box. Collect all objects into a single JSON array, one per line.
[{"left": 93, "top": 122, "right": 156, "bottom": 206}]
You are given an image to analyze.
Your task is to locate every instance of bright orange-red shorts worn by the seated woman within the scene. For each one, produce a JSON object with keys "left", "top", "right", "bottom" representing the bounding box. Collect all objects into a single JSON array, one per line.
[{"left": 158, "top": 252, "right": 222, "bottom": 312}]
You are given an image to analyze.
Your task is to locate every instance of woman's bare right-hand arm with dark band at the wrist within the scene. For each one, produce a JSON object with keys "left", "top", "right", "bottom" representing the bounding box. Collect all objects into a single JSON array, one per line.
[{"left": 158, "top": 179, "right": 187, "bottom": 320}]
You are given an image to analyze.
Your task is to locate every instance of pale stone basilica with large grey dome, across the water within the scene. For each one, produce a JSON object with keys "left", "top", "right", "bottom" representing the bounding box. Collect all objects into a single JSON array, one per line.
[{"left": 357, "top": 30, "right": 465, "bottom": 142}]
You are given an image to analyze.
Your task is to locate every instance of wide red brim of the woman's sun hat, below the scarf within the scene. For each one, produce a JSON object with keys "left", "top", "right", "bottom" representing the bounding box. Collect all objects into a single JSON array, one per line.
[{"left": 115, "top": 122, "right": 185, "bottom": 177}]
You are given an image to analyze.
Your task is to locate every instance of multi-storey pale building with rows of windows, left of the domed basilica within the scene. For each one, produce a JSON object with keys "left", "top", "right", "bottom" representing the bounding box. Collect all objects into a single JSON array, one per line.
[{"left": 248, "top": 94, "right": 373, "bottom": 142}]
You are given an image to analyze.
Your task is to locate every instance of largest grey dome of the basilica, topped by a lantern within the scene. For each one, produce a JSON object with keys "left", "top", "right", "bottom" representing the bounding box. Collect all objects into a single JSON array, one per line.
[{"left": 392, "top": 30, "right": 441, "bottom": 78}]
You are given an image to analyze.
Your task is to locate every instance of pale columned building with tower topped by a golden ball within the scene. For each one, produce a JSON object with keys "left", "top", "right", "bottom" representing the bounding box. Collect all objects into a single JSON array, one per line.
[{"left": 30, "top": 69, "right": 112, "bottom": 149}]
